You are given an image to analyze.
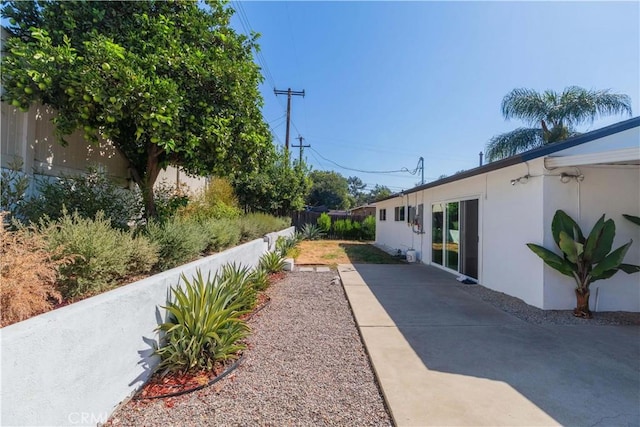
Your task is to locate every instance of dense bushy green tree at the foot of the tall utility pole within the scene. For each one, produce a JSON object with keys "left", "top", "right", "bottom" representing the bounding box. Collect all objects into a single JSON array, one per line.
[{"left": 233, "top": 151, "right": 311, "bottom": 216}]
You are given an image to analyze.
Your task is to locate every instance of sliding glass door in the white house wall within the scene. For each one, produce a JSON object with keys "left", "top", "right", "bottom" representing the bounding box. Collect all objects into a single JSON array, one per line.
[{"left": 431, "top": 199, "right": 478, "bottom": 279}]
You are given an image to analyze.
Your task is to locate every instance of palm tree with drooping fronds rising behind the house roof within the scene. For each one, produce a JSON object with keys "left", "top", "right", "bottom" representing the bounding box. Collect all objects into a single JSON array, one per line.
[{"left": 485, "top": 86, "right": 631, "bottom": 161}]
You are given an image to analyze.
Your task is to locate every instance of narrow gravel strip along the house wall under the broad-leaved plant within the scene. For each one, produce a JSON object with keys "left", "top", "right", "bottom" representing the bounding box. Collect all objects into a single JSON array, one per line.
[{"left": 457, "top": 285, "right": 640, "bottom": 326}]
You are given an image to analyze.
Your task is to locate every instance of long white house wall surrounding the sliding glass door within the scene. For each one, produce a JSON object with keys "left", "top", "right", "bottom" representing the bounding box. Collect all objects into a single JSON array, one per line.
[{"left": 376, "top": 159, "right": 544, "bottom": 307}]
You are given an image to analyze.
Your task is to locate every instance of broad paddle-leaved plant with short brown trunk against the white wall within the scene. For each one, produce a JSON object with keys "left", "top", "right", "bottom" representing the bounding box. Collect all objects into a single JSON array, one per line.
[{"left": 527, "top": 210, "right": 640, "bottom": 318}]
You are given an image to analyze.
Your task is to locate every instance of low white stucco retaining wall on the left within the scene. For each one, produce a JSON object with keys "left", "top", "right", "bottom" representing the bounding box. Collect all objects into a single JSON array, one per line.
[{"left": 0, "top": 227, "right": 294, "bottom": 426}]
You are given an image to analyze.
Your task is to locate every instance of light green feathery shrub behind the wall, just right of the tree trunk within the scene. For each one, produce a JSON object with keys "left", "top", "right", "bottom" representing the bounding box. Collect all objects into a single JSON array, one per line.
[{"left": 144, "top": 216, "right": 209, "bottom": 270}]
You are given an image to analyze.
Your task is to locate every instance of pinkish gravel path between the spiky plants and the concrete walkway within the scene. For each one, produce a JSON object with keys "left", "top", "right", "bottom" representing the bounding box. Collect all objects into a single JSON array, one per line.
[{"left": 110, "top": 272, "right": 392, "bottom": 426}]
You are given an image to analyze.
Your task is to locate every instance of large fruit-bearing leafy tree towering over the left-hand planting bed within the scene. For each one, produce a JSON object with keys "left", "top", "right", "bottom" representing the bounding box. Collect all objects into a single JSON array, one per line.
[{"left": 2, "top": 0, "right": 273, "bottom": 216}]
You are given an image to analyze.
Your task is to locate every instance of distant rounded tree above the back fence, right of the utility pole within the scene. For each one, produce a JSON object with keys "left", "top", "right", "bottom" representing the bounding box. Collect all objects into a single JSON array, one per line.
[{"left": 307, "top": 171, "right": 351, "bottom": 209}]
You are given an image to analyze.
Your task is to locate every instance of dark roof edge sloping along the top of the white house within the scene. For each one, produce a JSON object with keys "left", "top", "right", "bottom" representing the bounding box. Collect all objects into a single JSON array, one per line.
[{"left": 378, "top": 117, "right": 640, "bottom": 202}]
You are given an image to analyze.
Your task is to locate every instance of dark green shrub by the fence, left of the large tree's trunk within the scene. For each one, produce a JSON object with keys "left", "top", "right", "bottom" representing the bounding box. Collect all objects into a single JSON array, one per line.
[{"left": 23, "top": 167, "right": 142, "bottom": 229}]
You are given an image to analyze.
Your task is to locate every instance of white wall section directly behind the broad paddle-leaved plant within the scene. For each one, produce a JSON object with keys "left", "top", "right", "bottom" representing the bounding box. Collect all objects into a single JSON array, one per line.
[{"left": 544, "top": 166, "right": 640, "bottom": 312}]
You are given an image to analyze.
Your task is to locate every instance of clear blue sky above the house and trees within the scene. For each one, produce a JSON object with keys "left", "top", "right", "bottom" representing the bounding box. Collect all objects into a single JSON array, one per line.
[{"left": 231, "top": 1, "right": 640, "bottom": 191}]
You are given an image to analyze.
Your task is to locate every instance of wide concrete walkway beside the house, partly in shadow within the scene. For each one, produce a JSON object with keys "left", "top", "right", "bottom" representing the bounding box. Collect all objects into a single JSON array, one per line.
[{"left": 338, "top": 264, "right": 640, "bottom": 426}]
